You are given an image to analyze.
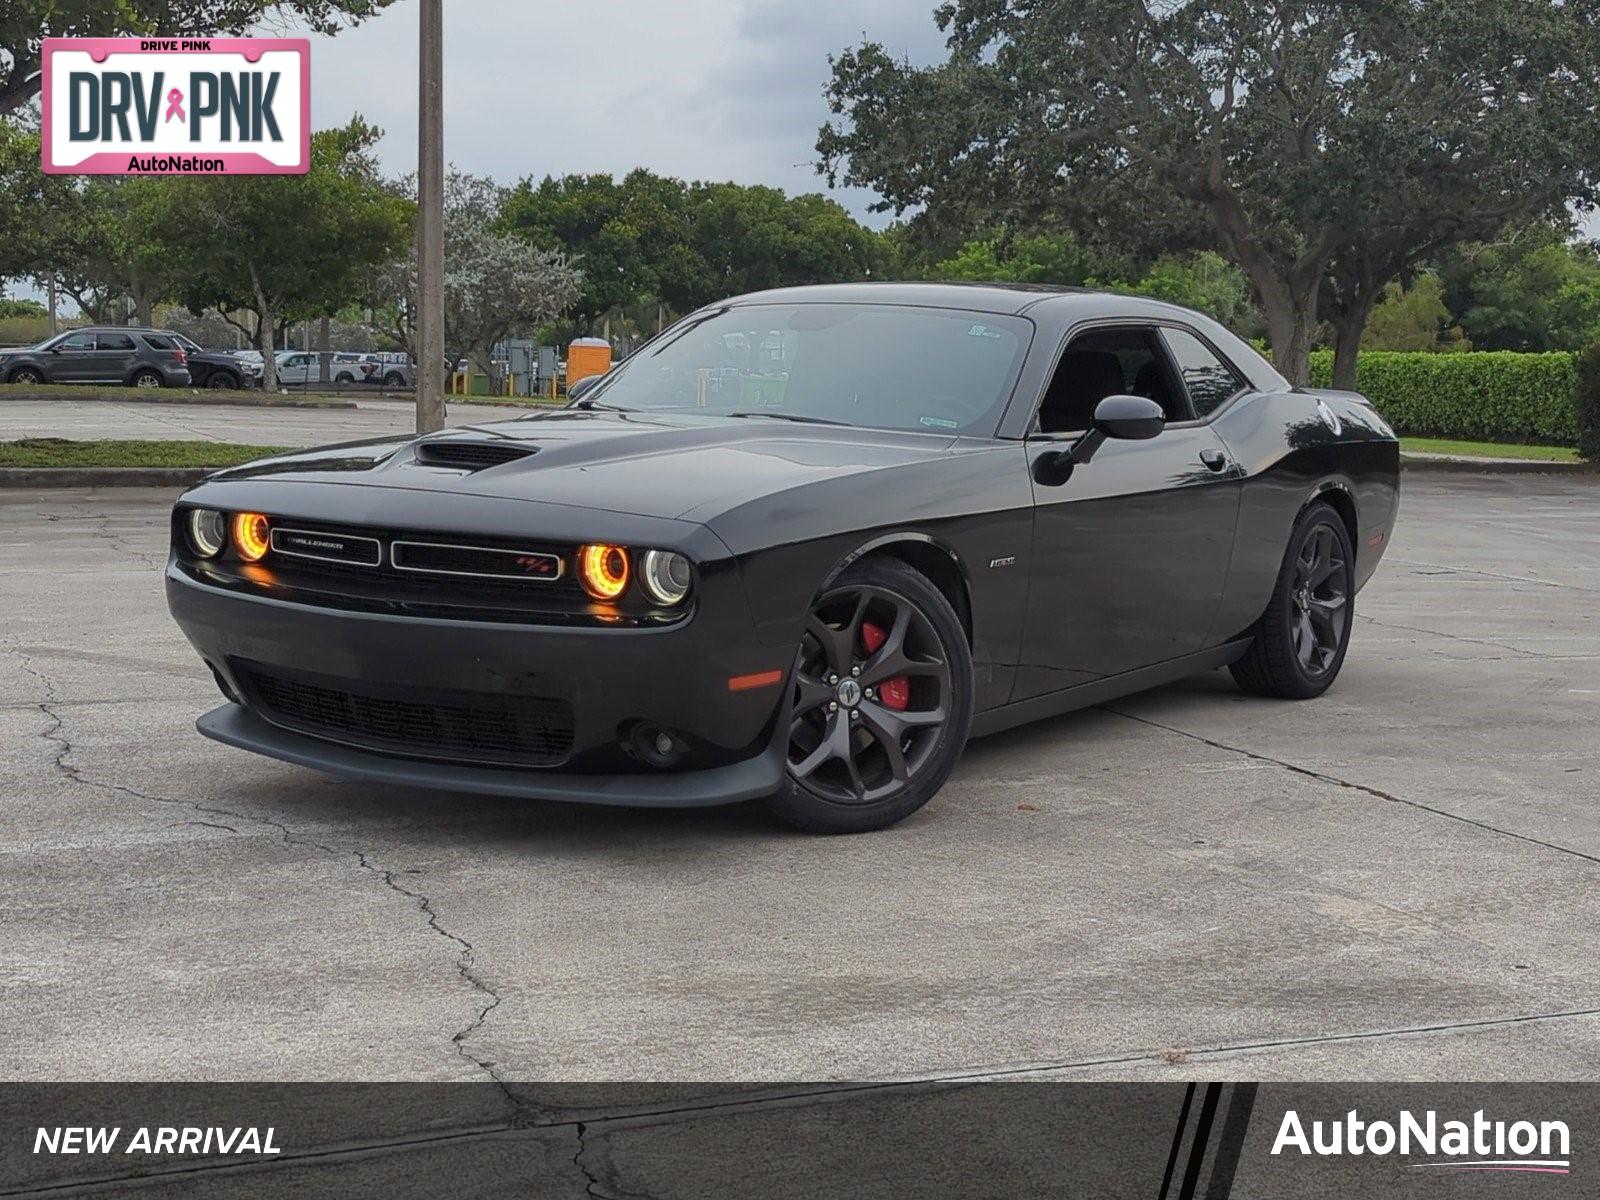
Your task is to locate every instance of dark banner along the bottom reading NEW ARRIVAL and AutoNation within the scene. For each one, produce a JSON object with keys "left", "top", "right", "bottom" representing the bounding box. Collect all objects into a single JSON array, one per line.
[{"left": 0, "top": 1082, "right": 1600, "bottom": 1200}]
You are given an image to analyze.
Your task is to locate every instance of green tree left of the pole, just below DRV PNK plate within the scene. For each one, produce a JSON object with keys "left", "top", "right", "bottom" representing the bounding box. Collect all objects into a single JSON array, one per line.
[{"left": 150, "top": 117, "right": 413, "bottom": 390}]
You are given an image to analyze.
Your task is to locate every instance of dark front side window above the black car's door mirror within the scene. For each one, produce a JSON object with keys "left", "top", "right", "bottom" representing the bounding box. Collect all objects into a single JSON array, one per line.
[{"left": 1038, "top": 325, "right": 1192, "bottom": 434}]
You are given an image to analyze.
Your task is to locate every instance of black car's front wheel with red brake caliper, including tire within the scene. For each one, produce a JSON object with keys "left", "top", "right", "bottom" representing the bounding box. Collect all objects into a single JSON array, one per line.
[{"left": 768, "top": 558, "right": 973, "bottom": 834}]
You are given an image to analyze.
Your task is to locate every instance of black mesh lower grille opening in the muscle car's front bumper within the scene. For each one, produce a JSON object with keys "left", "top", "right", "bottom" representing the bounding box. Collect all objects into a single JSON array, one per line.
[{"left": 234, "top": 664, "right": 573, "bottom": 765}]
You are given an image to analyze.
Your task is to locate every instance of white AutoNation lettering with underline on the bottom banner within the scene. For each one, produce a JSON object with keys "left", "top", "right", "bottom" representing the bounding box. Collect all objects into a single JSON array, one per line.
[{"left": 1272, "top": 1109, "right": 1571, "bottom": 1174}]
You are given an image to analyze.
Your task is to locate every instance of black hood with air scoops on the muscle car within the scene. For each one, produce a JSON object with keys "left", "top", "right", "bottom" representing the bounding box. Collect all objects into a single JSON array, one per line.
[{"left": 211, "top": 408, "right": 957, "bottom": 520}]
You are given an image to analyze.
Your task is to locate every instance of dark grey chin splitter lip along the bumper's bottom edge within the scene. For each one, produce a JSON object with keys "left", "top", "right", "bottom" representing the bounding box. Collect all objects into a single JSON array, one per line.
[{"left": 195, "top": 704, "right": 784, "bottom": 808}]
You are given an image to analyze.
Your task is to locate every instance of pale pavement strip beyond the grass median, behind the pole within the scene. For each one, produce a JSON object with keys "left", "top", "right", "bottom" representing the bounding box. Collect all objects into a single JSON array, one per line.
[{"left": 0, "top": 397, "right": 537, "bottom": 446}]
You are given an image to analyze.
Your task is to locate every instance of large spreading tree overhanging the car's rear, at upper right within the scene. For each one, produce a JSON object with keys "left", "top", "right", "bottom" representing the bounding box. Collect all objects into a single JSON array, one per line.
[{"left": 818, "top": 0, "right": 1600, "bottom": 382}]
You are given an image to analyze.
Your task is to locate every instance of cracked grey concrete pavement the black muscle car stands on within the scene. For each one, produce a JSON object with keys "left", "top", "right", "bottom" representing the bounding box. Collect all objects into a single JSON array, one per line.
[{"left": 0, "top": 474, "right": 1600, "bottom": 1085}]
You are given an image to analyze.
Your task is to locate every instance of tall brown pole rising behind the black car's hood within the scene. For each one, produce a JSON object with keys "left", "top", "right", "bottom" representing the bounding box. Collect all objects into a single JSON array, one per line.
[{"left": 416, "top": 0, "right": 445, "bottom": 434}]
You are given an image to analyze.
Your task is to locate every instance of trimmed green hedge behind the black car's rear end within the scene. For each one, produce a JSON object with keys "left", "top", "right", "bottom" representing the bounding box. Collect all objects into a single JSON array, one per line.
[{"left": 1310, "top": 350, "right": 1578, "bottom": 446}]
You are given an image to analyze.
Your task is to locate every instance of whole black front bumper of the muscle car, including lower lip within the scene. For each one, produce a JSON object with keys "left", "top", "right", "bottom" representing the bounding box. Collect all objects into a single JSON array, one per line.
[{"left": 166, "top": 560, "right": 787, "bottom": 805}]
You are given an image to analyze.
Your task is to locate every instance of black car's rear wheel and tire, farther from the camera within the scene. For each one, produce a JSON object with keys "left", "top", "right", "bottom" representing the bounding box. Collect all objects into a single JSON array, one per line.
[{"left": 1229, "top": 504, "right": 1355, "bottom": 699}]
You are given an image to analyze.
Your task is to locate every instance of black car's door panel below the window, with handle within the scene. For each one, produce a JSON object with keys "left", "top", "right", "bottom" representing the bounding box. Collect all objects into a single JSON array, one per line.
[{"left": 1013, "top": 426, "right": 1242, "bottom": 699}]
